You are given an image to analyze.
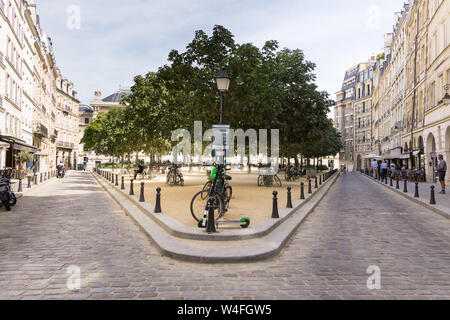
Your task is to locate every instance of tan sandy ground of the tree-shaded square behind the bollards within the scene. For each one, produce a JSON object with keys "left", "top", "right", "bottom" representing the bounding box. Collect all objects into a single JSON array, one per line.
[{"left": 107, "top": 169, "right": 326, "bottom": 227}]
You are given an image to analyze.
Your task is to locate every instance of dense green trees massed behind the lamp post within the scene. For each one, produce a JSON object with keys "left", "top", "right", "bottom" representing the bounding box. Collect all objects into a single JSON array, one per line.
[{"left": 82, "top": 25, "right": 341, "bottom": 165}]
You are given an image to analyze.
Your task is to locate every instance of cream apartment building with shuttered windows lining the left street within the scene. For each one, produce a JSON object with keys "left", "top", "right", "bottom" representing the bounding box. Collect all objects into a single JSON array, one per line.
[{"left": 0, "top": 0, "right": 79, "bottom": 172}]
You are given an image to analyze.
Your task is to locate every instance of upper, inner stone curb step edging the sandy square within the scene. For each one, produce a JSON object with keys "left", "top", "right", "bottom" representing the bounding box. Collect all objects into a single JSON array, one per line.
[{"left": 92, "top": 173, "right": 336, "bottom": 241}]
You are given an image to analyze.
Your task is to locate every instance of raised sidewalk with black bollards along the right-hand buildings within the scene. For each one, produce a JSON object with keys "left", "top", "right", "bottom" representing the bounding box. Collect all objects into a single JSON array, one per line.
[{"left": 364, "top": 175, "right": 450, "bottom": 219}]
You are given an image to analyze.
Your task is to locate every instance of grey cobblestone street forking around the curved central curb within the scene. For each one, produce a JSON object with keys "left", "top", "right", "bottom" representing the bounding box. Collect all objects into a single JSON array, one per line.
[{"left": 0, "top": 172, "right": 450, "bottom": 299}]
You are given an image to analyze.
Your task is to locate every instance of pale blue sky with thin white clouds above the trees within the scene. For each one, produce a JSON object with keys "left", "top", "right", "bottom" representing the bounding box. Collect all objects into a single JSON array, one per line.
[{"left": 36, "top": 0, "right": 406, "bottom": 104}]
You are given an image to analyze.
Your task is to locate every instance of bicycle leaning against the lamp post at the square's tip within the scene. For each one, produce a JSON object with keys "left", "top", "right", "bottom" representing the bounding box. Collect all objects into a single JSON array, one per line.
[{"left": 190, "top": 164, "right": 233, "bottom": 224}]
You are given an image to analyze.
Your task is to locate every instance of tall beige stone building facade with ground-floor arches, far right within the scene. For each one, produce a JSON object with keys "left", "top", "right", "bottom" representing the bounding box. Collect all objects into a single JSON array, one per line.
[{"left": 335, "top": 0, "right": 450, "bottom": 181}]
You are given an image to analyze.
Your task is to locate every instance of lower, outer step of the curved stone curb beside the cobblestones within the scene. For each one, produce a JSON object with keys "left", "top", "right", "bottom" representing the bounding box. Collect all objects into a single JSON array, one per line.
[{"left": 93, "top": 173, "right": 339, "bottom": 263}]
